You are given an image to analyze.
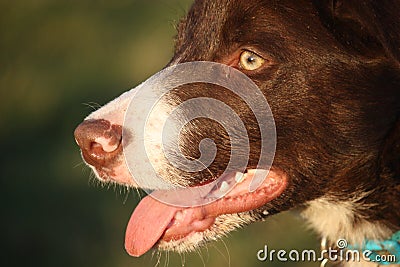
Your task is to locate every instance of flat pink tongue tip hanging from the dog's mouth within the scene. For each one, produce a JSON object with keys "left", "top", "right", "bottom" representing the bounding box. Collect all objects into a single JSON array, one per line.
[{"left": 125, "top": 196, "right": 178, "bottom": 257}]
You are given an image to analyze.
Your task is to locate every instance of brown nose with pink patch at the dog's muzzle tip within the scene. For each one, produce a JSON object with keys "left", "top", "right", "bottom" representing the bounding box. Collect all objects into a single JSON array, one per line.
[{"left": 74, "top": 120, "right": 122, "bottom": 167}]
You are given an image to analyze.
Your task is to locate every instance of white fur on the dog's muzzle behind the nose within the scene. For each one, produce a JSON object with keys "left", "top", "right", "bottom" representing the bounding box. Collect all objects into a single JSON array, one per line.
[{"left": 86, "top": 80, "right": 183, "bottom": 189}]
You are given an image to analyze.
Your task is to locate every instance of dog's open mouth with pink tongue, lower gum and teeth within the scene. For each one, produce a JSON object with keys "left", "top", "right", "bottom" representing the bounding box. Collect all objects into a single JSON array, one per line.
[{"left": 125, "top": 169, "right": 287, "bottom": 257}]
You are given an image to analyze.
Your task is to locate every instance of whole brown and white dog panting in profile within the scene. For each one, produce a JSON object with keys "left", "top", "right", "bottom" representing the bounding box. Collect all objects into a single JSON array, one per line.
[{"left": 75, "top": 0, "right": 400, "bottom": 266}]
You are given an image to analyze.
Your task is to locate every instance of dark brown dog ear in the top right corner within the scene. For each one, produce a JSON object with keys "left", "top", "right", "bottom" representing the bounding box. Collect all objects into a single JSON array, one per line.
[{"left": 313, "top": 0, "right": 400, "bottom": 64}]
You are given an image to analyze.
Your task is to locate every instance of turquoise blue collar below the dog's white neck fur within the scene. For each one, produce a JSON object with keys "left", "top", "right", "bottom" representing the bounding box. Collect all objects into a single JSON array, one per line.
[{"left": 348, "top": 231, "right": 400, "bottom": 265}]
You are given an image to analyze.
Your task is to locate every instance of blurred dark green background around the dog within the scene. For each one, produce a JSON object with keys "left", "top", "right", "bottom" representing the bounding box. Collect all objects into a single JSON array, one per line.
[{"left": 0, "top": 0, "right": 318, "bottom": 267}]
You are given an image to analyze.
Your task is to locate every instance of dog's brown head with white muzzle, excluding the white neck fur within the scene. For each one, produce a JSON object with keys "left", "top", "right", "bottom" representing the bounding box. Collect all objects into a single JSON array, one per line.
[{"left": 75, "top": 0, "right": 400, "bottom": 256}]
